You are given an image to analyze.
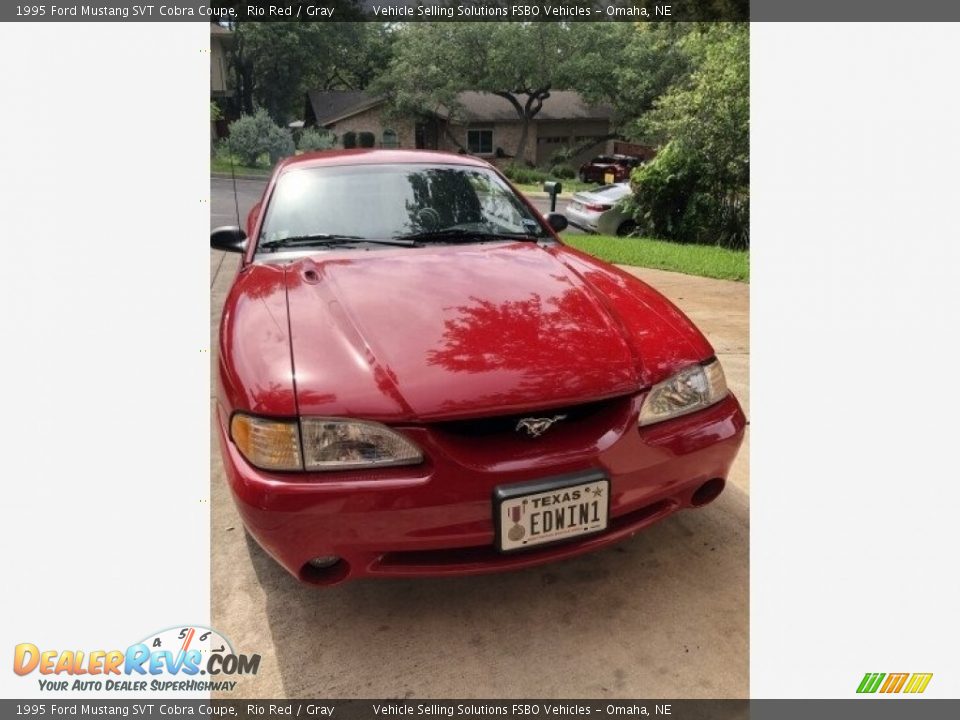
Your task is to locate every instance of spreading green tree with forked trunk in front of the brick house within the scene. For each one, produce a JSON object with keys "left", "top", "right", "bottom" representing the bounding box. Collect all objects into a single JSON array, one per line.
[{"left": 373, "top": 22, "right": 581, "bottom": 159}]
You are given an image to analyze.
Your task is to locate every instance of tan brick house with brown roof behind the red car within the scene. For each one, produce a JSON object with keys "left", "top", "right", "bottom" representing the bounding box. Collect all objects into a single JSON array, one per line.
[{"left": 304, "top": 90, "right": 614, "bottom": 166}]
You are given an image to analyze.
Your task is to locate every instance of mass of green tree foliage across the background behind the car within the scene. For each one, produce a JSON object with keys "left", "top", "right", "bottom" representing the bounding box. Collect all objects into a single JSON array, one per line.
[{"left": 219, "top": 19, "right": 750, "bottom": 247}]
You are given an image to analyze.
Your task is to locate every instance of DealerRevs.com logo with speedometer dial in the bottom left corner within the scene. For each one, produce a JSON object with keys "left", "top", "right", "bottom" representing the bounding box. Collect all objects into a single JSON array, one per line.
[{"left": 13, "top": 625, "right": 260, "bottom": 692}]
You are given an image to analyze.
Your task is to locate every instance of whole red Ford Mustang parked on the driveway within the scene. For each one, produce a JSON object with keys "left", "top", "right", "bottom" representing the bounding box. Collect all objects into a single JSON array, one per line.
[{"left": 211, "top": 150, "right": 745, "bottom": 585}]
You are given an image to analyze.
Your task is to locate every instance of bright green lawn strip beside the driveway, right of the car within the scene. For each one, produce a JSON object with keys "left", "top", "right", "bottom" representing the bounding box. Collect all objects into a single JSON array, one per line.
[{"left": 563, "top": 235, "right": 750, "bottom": 282}]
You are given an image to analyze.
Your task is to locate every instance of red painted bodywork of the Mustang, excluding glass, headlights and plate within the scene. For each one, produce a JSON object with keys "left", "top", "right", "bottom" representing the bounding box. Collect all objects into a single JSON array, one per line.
[{"left": 217, "top": 151, "right": 745, "bottom": 584}]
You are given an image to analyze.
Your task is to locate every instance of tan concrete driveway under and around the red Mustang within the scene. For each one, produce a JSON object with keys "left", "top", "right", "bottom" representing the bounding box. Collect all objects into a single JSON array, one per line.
[{"left": 210, "top": 179, "right": 749, "bottom": 698}]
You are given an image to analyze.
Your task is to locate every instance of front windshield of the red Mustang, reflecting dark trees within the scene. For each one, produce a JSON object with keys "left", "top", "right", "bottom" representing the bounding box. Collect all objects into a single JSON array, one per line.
[{"left": 260, "top": 164, "right": 548, "bottom": 247}]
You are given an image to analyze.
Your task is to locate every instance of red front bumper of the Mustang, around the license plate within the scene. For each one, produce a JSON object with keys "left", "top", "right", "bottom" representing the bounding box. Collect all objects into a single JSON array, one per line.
[{"left": 218, "top": 395, "right": 746, "bottom": 585}]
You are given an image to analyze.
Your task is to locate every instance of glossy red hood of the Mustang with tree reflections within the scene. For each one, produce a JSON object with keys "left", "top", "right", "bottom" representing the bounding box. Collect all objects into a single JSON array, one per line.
[{"left": 286, "top": 242, "right": 702, "bottom": 422}]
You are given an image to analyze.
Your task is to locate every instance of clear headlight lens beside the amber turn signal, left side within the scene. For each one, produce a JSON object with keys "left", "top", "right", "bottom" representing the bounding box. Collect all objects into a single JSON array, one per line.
[{"left": 300, "top": 418, "right": 423, "bottom": 470}]
